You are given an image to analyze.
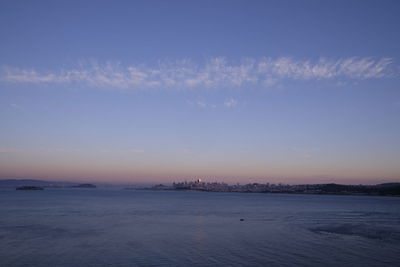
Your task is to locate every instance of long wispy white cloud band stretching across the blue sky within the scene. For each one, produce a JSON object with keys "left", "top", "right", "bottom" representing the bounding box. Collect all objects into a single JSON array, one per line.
[{"left": 1, "top": 57, "right": 394, "bottom": 90}]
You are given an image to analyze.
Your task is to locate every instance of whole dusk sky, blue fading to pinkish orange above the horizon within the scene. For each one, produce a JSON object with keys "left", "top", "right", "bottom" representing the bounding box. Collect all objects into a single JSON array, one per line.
[{"left": 0, "top": 0, "right": 400, "bottom": 184}]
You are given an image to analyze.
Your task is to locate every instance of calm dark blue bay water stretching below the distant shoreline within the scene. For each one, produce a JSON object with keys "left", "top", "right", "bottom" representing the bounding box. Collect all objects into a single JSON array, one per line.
[{"left": 0, "top": 189, "right": 400, "bottom": 266}]
